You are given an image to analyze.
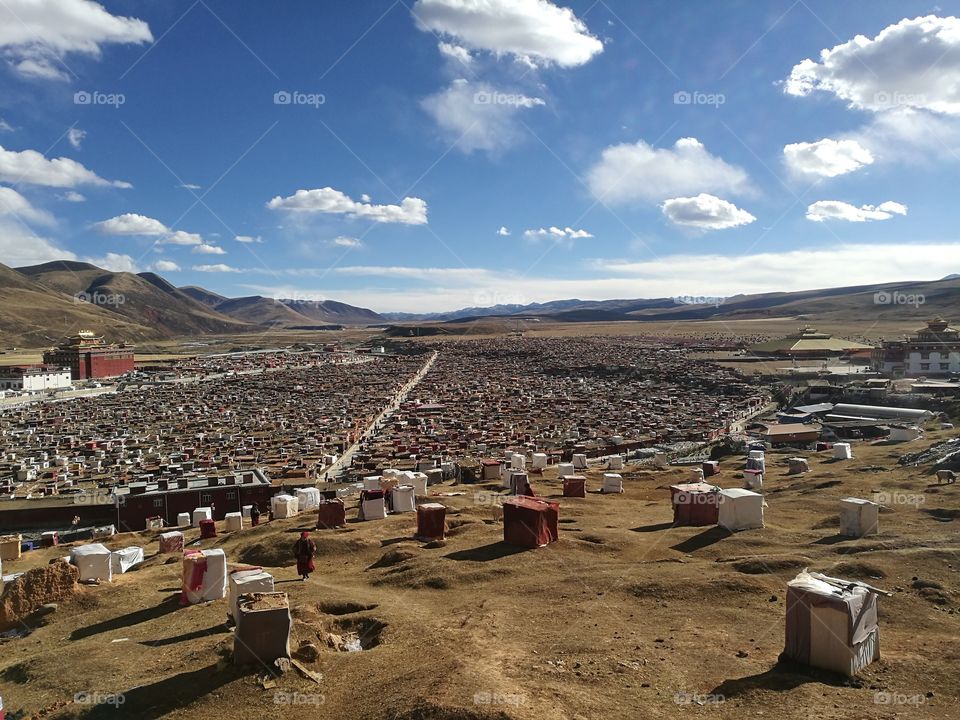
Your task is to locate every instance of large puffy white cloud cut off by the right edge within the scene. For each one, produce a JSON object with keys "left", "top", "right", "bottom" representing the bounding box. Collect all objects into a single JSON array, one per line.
[{"left": 784, "top": 15, "right": 960, "bottom": 115}]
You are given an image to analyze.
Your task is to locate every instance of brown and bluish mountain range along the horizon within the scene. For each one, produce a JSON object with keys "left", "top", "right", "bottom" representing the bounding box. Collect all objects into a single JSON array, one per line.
[{"left": 0, "top": 260, "right": 960, "bottom": 347}]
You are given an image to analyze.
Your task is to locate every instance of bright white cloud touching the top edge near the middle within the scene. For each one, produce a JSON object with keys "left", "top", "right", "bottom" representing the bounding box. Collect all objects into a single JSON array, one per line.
[{"left": 413, "top": 0, "right": 603, "bottom": 67}]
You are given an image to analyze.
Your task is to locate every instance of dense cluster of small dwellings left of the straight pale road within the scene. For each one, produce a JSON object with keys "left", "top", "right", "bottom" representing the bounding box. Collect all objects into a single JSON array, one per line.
[{"left": 0, "top": 353, "right": 424, "bottom": 497}]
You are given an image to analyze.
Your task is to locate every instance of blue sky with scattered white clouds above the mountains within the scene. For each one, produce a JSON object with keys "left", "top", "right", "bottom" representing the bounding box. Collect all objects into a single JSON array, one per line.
[{"left": 0, "top": 0, "right": 960, "bottom": 312}]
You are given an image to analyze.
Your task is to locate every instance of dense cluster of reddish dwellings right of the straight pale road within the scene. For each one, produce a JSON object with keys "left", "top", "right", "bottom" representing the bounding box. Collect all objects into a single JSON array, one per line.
[{"left": 354, "top": 337, "right": 769, "bottom": 472}]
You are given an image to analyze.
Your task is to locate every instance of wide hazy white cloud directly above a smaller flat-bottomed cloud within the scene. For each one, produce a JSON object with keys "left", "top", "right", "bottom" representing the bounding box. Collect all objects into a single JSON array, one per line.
[{"left": 587, "top": 138, "right": 751, "bottom": 204}]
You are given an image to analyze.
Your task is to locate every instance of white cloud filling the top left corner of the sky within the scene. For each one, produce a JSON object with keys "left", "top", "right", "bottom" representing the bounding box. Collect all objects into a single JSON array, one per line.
[{"left": 0, "top": 0, "right": 153, "bottom": 80}]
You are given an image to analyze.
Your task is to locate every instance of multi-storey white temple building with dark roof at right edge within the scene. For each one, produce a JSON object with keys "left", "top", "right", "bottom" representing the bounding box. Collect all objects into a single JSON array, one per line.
[{"left": 872, "top": 318, "right": 960, "bottom": 377}]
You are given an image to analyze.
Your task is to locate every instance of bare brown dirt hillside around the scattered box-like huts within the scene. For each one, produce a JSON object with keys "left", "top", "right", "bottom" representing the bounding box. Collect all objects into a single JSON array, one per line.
[{"left": 0, "top": 431, "right": 960, "bottom": 720}]
